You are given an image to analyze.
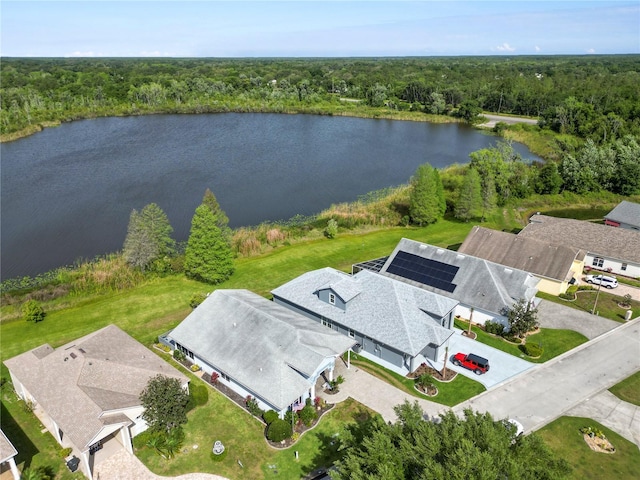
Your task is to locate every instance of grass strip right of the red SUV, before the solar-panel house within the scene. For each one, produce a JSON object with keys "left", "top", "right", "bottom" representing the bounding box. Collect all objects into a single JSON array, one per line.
[{"left": 454, "top": 319, "right": 588, "bottom": 363}]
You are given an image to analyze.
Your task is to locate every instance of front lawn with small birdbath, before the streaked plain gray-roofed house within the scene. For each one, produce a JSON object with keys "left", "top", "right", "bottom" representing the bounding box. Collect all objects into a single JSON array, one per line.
[{"left": 134, "top": 366, "right": 376, "bottom": 480}]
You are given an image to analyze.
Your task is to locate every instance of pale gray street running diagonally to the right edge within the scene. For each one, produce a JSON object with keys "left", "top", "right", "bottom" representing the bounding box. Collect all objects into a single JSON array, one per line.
[{"left": 454, "top": 318, "right": 640, "bottom": 436}]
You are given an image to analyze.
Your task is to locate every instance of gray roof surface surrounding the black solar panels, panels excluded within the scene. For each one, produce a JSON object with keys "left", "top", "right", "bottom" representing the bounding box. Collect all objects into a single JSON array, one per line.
[{"left": 380, "top": 238, "right": 539, "bottom": 315}]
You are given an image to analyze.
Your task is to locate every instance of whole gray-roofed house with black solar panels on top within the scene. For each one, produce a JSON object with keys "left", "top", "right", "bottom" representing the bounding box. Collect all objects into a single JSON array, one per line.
[{"left": 352, "top": 238, "right": 539, "bottom": 326}]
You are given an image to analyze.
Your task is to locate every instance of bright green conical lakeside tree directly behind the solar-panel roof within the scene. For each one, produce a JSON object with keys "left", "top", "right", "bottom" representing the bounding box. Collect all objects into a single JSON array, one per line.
[{"left": 409, "top": 163, "right": 447, "bottom": 226}]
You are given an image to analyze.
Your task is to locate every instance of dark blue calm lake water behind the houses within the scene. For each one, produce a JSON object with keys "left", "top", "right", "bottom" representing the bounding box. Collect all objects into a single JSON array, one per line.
[{"left": 0, "top": 113, "right": 535, "bottom": 279}]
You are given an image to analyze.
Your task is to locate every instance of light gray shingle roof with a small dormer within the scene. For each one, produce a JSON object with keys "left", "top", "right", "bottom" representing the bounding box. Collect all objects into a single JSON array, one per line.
[{"left": 271, "top": 268, "right": 458, "bottom": 355}]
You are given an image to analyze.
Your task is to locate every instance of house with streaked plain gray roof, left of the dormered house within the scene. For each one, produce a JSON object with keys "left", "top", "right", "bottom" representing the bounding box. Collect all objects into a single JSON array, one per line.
[{"left": 162, "top": 290, "right": 356, "bottom": 417}]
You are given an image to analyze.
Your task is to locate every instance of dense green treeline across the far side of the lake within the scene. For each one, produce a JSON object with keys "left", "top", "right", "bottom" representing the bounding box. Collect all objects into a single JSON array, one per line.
[{"left": 0, "top": 55, "right": 640, "bottom": 144}]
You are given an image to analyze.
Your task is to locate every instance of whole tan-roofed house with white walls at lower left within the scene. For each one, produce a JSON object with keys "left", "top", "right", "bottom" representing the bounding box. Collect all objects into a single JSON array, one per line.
[{"left": 4, "top": 325, "right": 189, "bottom": 478}]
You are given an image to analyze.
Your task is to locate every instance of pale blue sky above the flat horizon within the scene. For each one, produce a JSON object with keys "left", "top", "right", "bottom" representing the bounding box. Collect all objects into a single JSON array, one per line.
[{"left": 0, "top": 0, "right": 640, "bottom": 57}]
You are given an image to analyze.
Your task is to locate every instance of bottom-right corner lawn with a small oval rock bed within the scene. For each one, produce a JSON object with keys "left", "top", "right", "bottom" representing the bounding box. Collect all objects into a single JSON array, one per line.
[{"left": 538, "top": 417, "right": 640, "bottom": 480}]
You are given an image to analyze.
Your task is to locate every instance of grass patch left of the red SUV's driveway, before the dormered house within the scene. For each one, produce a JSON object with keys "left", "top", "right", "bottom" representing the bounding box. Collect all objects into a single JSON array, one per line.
[{"left": 344, "top": 354, "right": 485, "bottom": 407}]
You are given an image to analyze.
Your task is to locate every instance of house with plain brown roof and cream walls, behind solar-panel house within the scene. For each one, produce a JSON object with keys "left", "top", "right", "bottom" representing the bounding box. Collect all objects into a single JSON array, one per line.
[{"left": 458, "top": 226, "right": 585, "bottom": 295}]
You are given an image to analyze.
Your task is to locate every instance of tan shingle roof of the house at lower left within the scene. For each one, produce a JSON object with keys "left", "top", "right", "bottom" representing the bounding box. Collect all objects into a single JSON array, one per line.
[{"left": 4, "top": 325, "right": 188, "bottom": 450}]
